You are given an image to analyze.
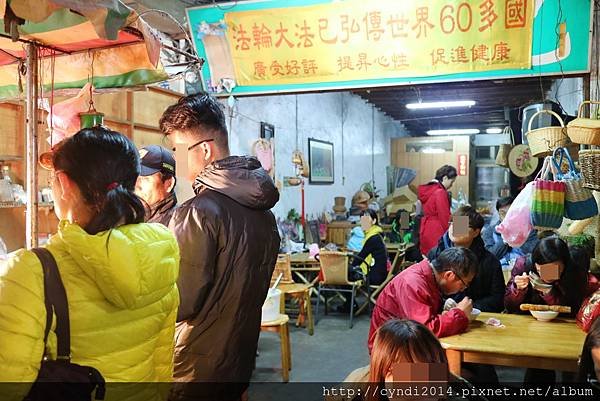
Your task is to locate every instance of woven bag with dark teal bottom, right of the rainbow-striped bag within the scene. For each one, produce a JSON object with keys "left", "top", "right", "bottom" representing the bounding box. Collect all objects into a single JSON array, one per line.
[{"left": 552, "top": 148, "right": 598, "bottom": 220}]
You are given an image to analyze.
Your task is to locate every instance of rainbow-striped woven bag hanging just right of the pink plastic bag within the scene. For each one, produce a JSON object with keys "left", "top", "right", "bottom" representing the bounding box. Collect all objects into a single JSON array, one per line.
[{"left": 531, "top": 156, "right": 566, "bottom": 231}]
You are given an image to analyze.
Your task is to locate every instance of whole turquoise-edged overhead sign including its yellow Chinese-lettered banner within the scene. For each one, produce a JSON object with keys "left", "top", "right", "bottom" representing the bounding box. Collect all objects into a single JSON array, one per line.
[{"left": 187, "top": 0, "right": 592, "bottom": 94}]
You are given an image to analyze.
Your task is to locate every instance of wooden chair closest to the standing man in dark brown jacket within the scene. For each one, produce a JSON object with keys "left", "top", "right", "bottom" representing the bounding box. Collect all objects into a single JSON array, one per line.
[{"left": 271, "top": 254, "right": 315, "bottom": 336}]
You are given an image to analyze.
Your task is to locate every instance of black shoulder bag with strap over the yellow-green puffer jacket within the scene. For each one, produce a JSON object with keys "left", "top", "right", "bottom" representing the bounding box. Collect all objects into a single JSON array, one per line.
[{"left": 24, "top": 248, "right": 106, "bottom": 401}]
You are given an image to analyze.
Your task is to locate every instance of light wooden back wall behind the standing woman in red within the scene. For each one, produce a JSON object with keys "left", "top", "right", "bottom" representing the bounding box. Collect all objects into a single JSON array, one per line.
[{"left": 391, "top": 135, "right": 473, "bottom": 199}]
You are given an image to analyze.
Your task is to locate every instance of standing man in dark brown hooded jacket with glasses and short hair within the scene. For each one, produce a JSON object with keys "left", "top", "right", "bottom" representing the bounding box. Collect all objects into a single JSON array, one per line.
[{"left": 160, "top": 94, "right": 280, "bottom": 401}]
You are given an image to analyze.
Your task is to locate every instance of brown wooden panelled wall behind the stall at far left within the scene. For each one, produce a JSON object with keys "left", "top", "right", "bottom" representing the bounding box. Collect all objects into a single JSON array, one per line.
[{"left": 0, "top": 88, "right": 181, "bottom": 251}]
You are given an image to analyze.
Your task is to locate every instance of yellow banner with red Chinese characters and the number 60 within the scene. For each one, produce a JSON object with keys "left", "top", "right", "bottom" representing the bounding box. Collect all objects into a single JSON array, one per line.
[{"left": 225, "top": 0, "right": 534, "bottom": 86}]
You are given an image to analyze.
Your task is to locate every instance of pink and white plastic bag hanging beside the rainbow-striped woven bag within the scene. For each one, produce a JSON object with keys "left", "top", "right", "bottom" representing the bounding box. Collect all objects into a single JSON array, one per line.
[{"left": 496, "top": 182, "right": 533, "bottom": 248}]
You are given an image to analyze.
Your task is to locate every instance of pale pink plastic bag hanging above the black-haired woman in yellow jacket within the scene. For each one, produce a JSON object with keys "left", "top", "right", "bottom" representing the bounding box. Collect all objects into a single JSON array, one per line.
[{"left": 47, "top": 82, "right": 90, "bottom": 145}]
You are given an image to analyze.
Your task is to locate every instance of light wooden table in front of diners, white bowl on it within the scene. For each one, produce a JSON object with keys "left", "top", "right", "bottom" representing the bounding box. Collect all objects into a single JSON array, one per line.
[{"left": 440, "top": 312, "right": 585, "bottom": 375}]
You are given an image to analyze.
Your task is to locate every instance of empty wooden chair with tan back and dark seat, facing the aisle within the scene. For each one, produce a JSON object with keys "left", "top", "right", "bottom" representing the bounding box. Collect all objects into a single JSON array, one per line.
[{"left": 315, "top": 251, "right": 369, "bottom": 328}]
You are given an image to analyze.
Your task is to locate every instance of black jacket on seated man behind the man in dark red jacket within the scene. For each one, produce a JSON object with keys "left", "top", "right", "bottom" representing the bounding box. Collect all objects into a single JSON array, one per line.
[{"left": 428, "top": 232, "right": 505, "bottom": 312}]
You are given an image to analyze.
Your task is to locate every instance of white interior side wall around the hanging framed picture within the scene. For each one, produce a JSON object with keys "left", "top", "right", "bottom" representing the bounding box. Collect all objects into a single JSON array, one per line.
[{"left": 223, "top": 93, "right": 406, "bottom": 217}]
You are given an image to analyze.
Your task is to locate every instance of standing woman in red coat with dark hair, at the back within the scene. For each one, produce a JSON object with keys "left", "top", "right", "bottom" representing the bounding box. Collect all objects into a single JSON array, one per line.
[{"left": 419, "top": 165, "right": 457, "bottom": 255}]
